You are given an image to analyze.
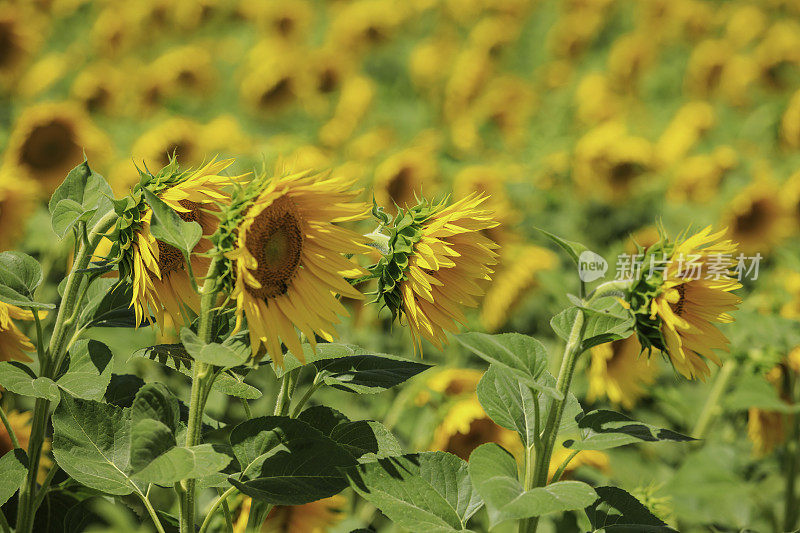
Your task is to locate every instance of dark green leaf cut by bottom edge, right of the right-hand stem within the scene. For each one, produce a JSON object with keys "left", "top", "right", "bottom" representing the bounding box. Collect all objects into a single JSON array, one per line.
[{"left": 586, "top": 487, "right": 675, "bottom": 533}]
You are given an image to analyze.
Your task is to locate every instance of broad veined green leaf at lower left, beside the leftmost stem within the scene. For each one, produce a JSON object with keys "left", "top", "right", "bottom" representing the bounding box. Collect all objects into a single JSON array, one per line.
[{"left": 53, "top": 392, "right": 139, "bottom": 496}]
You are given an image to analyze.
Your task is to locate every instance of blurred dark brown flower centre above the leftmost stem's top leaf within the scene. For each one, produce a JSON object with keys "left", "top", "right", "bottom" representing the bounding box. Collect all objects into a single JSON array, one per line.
[{"left": 20, "top": 119, "right": 80, "bottom": 171}]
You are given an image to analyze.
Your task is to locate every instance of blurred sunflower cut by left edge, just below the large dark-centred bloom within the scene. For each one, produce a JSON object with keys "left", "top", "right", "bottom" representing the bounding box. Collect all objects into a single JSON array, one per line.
[{"left": 0, "top": 165, "right": 38, "bottom": 250}]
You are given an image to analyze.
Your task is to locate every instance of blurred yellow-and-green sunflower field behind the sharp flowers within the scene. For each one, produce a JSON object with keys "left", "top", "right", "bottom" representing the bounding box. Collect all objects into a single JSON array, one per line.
[{"left": 0, "top": 0, "right": 800, "bottom": 533}]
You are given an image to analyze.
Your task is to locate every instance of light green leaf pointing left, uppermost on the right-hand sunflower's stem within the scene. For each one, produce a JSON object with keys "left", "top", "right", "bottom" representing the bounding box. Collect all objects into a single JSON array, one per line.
[{"left": 456, "top": 332, "right": 563, "bottom": 399}]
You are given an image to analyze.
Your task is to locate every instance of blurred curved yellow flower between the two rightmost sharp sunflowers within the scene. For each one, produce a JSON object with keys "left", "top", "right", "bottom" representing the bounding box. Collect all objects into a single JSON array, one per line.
[{"left": 480, "top": 244, "right": 558, "bottom": 332}]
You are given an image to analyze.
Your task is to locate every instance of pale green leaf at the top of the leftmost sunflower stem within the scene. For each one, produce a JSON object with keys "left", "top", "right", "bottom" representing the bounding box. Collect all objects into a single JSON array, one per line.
[{"left": 48, "top": 161, "right": 114, "bottom": 238}]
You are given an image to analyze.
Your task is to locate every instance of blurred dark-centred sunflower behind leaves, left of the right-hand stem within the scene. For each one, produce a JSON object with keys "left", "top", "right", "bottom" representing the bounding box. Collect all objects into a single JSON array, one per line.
[{"left": 430, "top": 393, "right": 523, "bottom": 461}]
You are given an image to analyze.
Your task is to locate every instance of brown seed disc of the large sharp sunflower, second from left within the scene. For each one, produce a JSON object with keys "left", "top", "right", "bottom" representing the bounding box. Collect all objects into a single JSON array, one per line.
[{"left": 245, "top": 196, "right": 303, "bottom": 299}]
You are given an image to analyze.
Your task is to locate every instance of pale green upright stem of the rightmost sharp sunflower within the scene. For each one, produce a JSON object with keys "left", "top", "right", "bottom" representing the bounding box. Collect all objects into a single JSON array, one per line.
[{"left": 520, "top": 308, "right": 588, "bottom": 533}]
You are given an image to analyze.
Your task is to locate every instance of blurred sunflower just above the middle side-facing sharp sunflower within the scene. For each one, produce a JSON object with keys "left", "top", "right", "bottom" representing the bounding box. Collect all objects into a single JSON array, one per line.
[{"left": 372, "top": 147, "right": 438, "bottom": 214}]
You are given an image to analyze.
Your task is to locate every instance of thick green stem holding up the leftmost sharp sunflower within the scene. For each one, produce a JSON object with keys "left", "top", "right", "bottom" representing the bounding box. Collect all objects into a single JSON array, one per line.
[{"left": 16, "top": 211, "right": 117, "bottom": 533}]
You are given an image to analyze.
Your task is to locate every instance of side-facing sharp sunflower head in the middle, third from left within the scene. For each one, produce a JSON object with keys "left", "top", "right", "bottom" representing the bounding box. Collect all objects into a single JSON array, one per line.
[{"left": 373, "top": 194, "right": 497, "bottom": 350}]
